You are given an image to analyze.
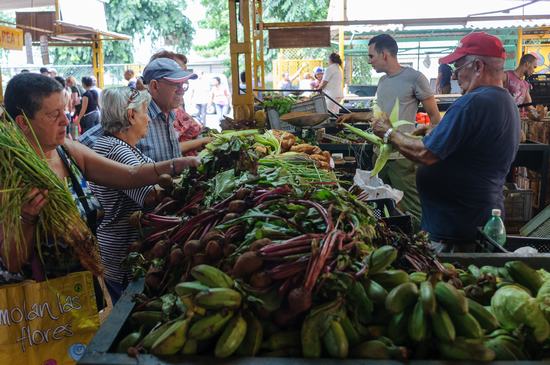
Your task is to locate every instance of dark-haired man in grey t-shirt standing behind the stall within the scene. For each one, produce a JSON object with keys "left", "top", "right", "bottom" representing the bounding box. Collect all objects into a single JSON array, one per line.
[{"left": 339, "top": 34, "right": 441, "bottom": 227}]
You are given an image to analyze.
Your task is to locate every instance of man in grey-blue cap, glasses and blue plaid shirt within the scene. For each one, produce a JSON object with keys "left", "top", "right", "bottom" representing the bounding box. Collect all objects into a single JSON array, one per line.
[{"left": 79, "top": 58, "right": 201, "bottom": 162}]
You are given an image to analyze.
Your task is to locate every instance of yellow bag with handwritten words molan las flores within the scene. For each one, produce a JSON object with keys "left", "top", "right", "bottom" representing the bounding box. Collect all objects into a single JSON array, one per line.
[{"left": 0, "top": 271, "right": 99, "bottom": 365}]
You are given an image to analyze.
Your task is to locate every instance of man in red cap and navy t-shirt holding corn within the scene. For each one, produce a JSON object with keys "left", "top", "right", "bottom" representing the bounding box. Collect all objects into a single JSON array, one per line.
[{"left": 373, "top": 32, "right": 520, "bottom": 252}]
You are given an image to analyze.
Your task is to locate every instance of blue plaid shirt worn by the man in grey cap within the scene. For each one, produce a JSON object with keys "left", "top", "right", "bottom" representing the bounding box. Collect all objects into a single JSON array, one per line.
[{"left": 78, "top": 100, "right": 181, "bottom": 162}]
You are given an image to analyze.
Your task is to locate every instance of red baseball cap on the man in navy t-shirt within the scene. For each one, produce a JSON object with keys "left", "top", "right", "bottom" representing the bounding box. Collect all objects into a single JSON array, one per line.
[{"left": 439, "top": 32, "right": 506, "bottom": 63}]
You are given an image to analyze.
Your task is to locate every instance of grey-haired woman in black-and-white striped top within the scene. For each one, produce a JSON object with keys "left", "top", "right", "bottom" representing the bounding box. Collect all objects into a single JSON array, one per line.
[{"left": 92, "top": 87, "right": 198, "bottom": 304}]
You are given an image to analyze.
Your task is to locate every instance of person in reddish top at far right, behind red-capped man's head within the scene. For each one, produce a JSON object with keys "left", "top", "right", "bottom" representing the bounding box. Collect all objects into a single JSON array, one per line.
[{"left": 503, "top": 53, "right": 537, "bottom": 105}]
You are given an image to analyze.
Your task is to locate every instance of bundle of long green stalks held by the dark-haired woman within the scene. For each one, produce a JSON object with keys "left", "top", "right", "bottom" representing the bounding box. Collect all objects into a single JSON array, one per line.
[{"left": 0, "top": 117, "right": 103, "bottom": 275}]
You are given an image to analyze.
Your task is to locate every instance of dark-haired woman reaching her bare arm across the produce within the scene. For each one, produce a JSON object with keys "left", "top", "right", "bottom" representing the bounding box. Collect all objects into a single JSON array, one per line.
[{"left": 0, "top": 73, "right": 198, "bottom": 282}]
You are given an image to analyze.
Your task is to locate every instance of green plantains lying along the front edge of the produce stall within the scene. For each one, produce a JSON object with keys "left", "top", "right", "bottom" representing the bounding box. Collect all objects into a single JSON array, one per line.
[{"left": 117, "top": 246, "right": 550, "bottom": 361}]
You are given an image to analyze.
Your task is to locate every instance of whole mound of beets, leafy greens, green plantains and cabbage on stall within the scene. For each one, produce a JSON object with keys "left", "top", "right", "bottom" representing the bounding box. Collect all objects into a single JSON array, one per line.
[{"left": 113, "top": 126, "right": 550, "bottom": 361}]
